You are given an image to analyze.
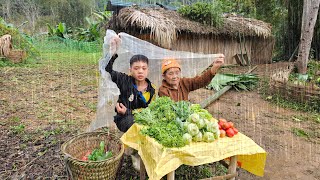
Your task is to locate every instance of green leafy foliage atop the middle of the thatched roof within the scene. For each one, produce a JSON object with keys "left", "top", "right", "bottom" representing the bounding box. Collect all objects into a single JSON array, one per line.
[{"left": 178, "top": 1, "right": 223, "bottom": 27}]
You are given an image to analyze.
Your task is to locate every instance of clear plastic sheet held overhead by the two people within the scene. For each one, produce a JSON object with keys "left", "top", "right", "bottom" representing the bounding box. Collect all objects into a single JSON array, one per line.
[{"left": 88, "top": 30, "right": 219, "bottom": 131}]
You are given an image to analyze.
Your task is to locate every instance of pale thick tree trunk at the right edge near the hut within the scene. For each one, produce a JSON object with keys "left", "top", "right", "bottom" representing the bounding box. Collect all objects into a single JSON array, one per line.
[{"left": 296, "top": 0, "right": 320, "bottom": 74}]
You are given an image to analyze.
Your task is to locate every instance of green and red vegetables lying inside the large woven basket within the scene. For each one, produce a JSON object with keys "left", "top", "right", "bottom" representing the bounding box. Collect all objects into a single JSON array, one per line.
[{"left": 81, "top": 141, "right": 112, "bottom": 161}]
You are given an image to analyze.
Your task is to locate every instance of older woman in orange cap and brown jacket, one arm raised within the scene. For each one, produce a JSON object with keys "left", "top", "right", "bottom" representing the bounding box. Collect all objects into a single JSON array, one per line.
[{"left": 159, "top": 54, "right": 224, "bottom": 101}]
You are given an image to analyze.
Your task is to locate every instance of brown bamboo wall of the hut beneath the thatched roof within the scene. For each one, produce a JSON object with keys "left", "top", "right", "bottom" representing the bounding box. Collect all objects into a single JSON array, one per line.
[{"left": 133, "top": 34, "right": 274, "bottom": 64}]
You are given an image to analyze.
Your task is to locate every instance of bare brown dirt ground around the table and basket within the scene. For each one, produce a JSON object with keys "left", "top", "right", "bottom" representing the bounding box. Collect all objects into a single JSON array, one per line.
[{"left": 0, "top": 61, "right": 320, "bottom": 180}]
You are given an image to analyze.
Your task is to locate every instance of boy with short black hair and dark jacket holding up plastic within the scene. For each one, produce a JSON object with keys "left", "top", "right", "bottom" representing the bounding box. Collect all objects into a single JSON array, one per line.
[{"left": 105, "top": 37, "right": 155, "bottom": 132}]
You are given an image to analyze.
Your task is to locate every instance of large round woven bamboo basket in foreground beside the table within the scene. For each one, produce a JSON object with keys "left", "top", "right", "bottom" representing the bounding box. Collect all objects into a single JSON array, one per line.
[{"left": 61, "top": 132, "right": 124, "bottom": 179}]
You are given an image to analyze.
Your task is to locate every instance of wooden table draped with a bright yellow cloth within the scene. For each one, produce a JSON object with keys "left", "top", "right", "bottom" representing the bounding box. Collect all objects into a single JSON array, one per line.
[{"left": 121, "top": 125, "right": 267, "bottom": 180}]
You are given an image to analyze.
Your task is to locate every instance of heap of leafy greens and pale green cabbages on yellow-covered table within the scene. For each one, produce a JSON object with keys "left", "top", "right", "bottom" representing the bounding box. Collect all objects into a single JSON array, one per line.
[{"left": 133, "top": 97, "right": 239, "bottom": 147}]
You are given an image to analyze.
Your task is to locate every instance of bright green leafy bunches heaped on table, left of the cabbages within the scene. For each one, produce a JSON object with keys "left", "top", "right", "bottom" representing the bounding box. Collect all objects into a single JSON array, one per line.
[{"left": 133, "top": 97, "right": 189, "bottom": 147}]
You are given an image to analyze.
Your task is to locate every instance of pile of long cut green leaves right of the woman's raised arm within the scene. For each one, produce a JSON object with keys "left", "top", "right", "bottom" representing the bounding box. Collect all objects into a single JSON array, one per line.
[{"left": 207, "top": 74, "right": 259, "bottom": 91}]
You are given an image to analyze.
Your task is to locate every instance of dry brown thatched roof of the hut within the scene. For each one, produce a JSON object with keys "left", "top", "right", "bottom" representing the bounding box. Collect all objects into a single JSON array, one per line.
[{"left": 117, "top": 7, "right": 271, "bottom": 47}]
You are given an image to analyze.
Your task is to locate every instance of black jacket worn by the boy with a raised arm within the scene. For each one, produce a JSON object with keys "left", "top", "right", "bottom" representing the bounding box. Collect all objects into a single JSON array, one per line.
[{"left": 105, "top": 54, "right": 155, "bottom": 116}]
